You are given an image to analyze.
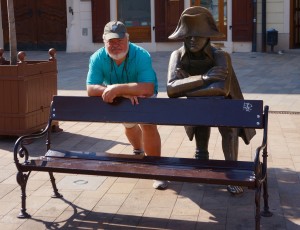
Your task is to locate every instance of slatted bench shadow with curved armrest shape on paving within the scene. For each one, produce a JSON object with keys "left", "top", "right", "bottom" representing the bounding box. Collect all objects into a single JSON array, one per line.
[{"left": 31, "top": 194, "right": 217, "bottom": 230}]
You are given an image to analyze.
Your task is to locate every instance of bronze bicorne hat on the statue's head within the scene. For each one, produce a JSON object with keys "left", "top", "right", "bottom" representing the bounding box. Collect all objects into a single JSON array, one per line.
[{"left": 169, "top": 6, "right": 224, "bottom": 39}]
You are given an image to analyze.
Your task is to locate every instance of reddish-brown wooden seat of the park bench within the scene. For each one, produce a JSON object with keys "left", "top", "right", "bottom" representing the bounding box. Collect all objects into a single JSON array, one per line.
[{"left": 22, "top": 157, "right": 255, "bottom": 188}]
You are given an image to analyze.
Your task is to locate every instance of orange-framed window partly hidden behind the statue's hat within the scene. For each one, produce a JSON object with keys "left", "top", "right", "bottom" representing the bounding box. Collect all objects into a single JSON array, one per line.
[{"left": 190, "top": 0, "right": 227, "bottom": 40}]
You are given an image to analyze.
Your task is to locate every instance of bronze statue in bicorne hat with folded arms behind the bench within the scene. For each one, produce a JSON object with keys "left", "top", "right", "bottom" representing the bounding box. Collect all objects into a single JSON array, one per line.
[{"left": 167, "top": 6, "right": 255, "bottom": 194}]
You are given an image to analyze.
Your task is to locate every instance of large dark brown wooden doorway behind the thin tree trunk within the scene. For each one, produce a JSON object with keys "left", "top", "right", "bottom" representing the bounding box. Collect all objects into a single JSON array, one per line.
[{"left": 1, "top": 0, "right": 67, "bottom": 50}]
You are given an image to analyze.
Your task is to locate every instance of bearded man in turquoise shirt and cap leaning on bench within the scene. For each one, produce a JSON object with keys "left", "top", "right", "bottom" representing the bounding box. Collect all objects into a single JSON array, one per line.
[{"left": 86, "top": 21, "right": 167, "bottom": 189}]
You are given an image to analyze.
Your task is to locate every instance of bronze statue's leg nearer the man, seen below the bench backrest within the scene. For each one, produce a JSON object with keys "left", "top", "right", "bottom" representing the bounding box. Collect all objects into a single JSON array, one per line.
[{"left": 195, "top": 126, "right": 210, "bottom": 160}]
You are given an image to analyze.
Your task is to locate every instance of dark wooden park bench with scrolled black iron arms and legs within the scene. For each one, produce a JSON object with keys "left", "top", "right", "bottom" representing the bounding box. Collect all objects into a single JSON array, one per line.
[{"left": 14, "top": 96, "right": 271, "bottom": 229}]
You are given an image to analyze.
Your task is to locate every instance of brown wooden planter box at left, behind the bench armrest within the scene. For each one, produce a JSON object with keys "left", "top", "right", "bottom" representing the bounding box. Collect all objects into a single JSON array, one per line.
[{"left": 0, "top": 56, "right": 57, "bottom": 136}]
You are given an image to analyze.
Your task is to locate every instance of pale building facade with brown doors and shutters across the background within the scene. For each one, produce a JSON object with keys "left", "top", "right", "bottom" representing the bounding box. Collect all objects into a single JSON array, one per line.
[{"left": 0, "top": 0, "right": 300, "bottom": 52}]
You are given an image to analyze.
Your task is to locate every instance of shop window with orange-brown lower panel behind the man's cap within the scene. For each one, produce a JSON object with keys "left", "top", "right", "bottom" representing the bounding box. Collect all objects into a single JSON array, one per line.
[{"left": 117, "top": 0, "right": 151, "bottom": 42}]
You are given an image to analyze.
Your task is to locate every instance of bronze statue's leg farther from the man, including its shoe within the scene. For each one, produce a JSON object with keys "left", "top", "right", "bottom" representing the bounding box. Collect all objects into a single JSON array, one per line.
[{"left": 219, "top": 127, "right": 244, "bottom": 195}]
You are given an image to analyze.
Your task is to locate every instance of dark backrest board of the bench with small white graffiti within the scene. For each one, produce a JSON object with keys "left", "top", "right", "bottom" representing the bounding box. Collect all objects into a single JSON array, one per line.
[{"left": 51, "top": 96, "right": 263, "bottom": 129}]
